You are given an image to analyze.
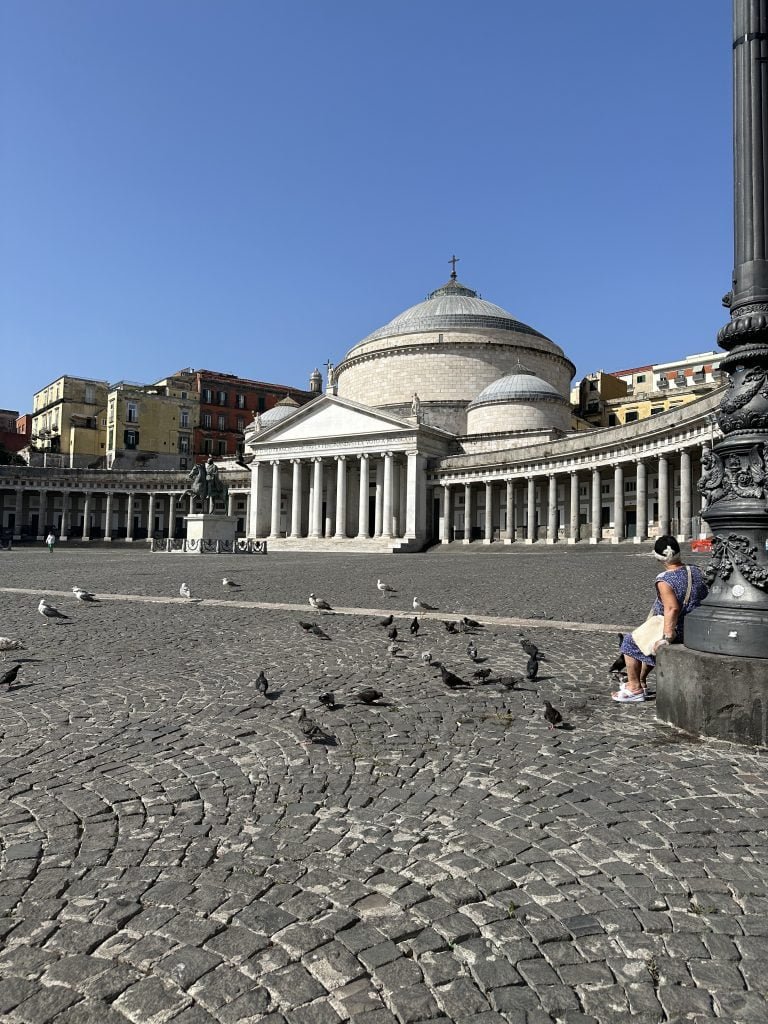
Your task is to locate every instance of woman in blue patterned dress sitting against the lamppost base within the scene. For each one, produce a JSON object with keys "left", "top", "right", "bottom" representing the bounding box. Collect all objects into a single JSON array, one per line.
[{"left": 611, "top": 537, "right": 708, "bottom": 703}]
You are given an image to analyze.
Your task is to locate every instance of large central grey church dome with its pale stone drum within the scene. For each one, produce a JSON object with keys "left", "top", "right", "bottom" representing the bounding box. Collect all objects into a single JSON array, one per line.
[{"left": 336, "top": 274, "right": 575, "bottom": 435}]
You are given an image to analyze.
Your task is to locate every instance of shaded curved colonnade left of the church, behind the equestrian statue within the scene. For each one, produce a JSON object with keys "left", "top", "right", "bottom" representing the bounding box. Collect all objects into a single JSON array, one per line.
[{"left": 0, "top": 481, "right": 251, "bottom": 542}]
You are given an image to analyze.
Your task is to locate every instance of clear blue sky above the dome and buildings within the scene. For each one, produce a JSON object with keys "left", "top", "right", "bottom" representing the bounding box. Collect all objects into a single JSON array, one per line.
[{"left": 0, "top": 0, "right": 732, "bottom": 411}]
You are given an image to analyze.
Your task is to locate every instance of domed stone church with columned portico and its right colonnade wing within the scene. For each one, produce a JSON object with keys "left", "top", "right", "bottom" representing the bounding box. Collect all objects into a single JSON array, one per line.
[{"left": 246, "top": 269, "right": 720, "bottom": 552}]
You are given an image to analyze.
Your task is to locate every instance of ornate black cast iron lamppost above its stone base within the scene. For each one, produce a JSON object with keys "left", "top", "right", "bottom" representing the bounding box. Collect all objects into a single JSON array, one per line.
[{"left": 685, "top": 0, "right": 768, "bottom": 657}]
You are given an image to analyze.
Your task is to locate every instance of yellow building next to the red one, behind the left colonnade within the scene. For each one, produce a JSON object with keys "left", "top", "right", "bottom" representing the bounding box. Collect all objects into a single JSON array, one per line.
[{"left": 106, "top": 374, "right": 200, "bottom": 469}]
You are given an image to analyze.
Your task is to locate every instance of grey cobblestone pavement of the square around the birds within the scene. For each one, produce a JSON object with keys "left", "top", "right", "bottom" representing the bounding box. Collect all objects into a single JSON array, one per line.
[{"left": 0, "top": 546, "right": 768, "bottom": 1024}]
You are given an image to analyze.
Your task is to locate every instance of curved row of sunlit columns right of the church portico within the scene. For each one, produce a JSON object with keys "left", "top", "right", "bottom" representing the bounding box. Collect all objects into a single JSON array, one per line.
[{"left": 434, "top": 446, "right": 702, "bottom": 544}]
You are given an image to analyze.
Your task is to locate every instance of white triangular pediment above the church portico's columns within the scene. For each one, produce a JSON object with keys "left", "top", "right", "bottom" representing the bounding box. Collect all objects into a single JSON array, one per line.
[{"left": 252, "top": 395, "right": 415, "bottom": 446}]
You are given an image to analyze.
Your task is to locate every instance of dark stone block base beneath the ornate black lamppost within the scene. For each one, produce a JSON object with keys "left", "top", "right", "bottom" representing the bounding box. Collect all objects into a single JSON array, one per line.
[{"left": 656, "top": 643, "right": 768, "bottom": 746}]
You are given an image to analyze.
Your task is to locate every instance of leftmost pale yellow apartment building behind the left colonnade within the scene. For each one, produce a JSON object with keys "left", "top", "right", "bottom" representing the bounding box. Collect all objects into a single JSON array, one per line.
[{"left": 31, "top": 375, "right": 110, "bottom": 468}]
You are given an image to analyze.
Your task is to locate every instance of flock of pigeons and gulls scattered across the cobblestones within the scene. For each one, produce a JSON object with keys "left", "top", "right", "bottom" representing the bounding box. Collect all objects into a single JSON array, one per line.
[{"left": 0, "top": 577, "right": 577, "bottom": 743}]
